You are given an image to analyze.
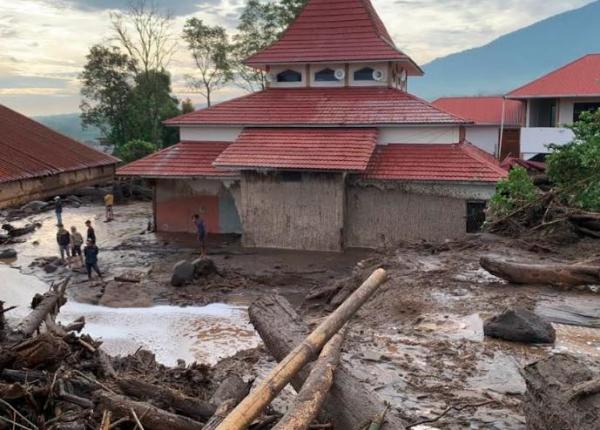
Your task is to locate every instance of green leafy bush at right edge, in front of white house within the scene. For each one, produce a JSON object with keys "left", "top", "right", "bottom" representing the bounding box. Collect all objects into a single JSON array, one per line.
[{"left": 546, "top": 109, "right": 600, "bottom": 211}]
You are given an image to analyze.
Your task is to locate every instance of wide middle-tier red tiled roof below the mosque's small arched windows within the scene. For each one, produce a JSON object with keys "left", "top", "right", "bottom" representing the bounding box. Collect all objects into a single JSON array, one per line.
[{"left": 165, "top": 87, "right": 467, "bottom": 126}]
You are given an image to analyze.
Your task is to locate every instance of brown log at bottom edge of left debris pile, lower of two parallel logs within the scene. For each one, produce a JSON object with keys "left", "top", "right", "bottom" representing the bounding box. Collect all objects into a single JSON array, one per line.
[{"left": 94, "top": 391, "right": 202, "bottom": 430}]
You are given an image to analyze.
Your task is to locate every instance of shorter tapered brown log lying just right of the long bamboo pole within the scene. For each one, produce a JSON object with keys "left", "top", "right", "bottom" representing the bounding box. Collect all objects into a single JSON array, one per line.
[{"left": 273, "top": 329, "right": 345, "bottom": 430}]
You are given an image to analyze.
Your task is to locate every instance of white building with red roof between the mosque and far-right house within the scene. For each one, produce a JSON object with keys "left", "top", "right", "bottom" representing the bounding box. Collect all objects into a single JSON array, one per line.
[{"left": 432, "top": 96, "right": 525, "bottom": 160}]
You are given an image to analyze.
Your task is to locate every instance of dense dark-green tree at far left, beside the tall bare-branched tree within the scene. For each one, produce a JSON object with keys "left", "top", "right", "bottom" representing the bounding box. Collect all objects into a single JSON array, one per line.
[{"left": 80, "top": 45, "right": 134, "bottom": 146}]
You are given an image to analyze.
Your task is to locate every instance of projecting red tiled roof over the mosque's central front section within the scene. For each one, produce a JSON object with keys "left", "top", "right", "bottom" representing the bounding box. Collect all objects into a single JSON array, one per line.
[{"left": 215, "top": 128, "right": 377, "bottom": 172}]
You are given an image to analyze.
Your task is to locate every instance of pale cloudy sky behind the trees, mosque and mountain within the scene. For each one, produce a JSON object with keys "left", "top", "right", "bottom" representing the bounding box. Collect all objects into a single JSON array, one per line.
[{"left": 0, "top": 0, "right": 591, "bottom": 116}]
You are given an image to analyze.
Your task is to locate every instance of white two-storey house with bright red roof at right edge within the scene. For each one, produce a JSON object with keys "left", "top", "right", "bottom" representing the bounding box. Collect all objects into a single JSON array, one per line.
[{"left": 506, "top": 53, "right": 600, "bottom": 160}]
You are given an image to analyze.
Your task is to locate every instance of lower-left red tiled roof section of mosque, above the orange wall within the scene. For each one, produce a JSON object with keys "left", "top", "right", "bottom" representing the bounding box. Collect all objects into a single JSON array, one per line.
[{"left": 117, "top": 142, "right": 236, "bottom": 178}]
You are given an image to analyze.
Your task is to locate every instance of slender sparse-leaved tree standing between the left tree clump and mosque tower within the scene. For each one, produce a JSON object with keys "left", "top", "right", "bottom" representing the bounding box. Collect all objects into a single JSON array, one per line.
[{"left": 183, "top": 18, "right": 233, "bottom": 106}]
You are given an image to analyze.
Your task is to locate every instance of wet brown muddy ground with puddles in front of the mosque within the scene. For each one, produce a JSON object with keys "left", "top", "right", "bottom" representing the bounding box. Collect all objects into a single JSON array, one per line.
[{"left": 0, "top": 203, "right": 600, "bottom": 429}]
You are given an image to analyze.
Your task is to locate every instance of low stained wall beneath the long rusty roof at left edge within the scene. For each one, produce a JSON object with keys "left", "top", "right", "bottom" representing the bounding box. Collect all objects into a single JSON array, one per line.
[{"left": 0, "top": 165, "right": 115, "bottom": 208}]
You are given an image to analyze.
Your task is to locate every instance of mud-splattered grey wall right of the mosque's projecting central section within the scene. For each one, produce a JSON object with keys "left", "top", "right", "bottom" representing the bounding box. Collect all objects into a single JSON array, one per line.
[{"left": 344, "top": 184, "right": 493, "bottom": 248}]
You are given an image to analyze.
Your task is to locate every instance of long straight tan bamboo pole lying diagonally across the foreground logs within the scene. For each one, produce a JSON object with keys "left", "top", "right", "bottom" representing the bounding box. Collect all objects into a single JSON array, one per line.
[{"left": 217, "top": 269, "right": 386, "bottom": 430}]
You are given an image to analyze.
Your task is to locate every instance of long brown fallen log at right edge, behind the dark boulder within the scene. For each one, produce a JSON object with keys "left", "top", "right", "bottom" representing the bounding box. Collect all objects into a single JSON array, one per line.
[{"left": 479, "top": 256, "right": 600, "bottom": 287}]
